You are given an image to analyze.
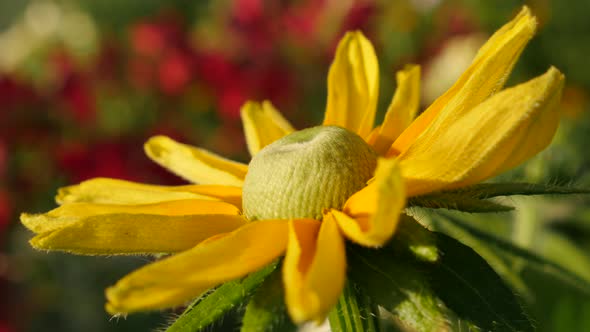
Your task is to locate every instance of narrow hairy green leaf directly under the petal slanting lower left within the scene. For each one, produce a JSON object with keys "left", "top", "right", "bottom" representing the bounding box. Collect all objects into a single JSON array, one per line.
[{"left": 167, "top": 262, "right": 277, "bottom": 332}]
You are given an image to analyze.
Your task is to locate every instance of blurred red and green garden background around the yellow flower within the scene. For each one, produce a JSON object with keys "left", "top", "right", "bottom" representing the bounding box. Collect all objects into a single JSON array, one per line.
[{"left": 0, "top": 0, "right": 590, "bottom": 332}]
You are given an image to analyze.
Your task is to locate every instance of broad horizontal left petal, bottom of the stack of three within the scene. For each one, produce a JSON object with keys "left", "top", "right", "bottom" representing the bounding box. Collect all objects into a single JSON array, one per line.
[{"left": 31, "top": 213, "right": 246, "bottom": 255}]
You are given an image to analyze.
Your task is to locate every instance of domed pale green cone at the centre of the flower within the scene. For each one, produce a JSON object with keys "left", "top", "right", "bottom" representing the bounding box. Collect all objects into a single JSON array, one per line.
[{"left": 242, "top": 126, "right": 377, "bottom": 220}]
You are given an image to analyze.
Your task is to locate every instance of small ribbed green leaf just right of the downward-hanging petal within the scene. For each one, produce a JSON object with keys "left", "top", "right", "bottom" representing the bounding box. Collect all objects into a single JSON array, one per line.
[{"left": 328, "top": 281, "right": 377, "bottom": 332}]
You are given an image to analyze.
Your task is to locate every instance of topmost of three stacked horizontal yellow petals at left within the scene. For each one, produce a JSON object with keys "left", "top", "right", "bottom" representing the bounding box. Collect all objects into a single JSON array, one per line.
[{"left": 55, "top": 178, "right": 241, "bottom": 204}]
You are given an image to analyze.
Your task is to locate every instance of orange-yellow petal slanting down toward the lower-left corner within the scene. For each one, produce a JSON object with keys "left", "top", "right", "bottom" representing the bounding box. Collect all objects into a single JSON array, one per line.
[{"left": 106, "top": 220, "right": 288, "bottom": 314}]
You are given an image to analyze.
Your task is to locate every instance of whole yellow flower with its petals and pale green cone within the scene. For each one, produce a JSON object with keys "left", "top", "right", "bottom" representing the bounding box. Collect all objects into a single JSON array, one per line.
[{"left": 21, "top": 7, "right": 564, "bottom": 322}]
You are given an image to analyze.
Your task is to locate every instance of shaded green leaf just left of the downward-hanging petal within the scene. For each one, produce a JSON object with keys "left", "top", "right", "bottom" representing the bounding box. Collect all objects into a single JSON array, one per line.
[{"left": 241, "top": 268, "right": 297, "bottom": 332}]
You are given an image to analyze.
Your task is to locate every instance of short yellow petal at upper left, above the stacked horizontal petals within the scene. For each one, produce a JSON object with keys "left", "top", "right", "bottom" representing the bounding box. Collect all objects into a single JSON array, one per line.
[{"left": 144, "top": 136, "right": 248, "bottom": 186}]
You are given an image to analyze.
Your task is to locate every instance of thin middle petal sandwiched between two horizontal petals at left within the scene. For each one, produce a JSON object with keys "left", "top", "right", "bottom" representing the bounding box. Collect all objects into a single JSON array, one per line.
[{"left": 20, "top": 199, "right": 240, "bottom": 233}]
